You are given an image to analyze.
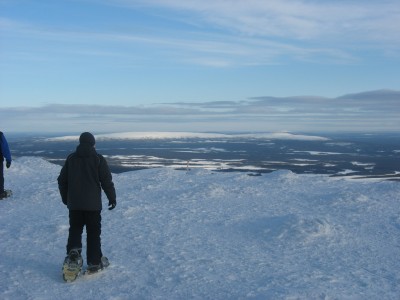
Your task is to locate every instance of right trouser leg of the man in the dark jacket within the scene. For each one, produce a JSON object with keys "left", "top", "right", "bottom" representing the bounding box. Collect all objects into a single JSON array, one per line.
[{"left": 85, "top": 211, "right": 103, "bottom": 265}]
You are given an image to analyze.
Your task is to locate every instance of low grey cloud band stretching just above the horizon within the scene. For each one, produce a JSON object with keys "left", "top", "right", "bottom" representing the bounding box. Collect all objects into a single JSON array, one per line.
[{"left": 0, "top": 90, "right": 400, "bottom": 132}]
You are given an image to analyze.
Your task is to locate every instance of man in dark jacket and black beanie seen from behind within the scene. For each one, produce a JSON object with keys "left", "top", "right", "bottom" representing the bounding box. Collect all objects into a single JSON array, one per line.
[{"left": 58, "top": 132, "right": 117, "bottom": 279}]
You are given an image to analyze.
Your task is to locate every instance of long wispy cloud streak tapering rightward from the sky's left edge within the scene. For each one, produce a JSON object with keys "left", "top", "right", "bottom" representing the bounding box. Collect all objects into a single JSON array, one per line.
[{"left": 0, "top": 19, "right": 355, "bottom": 68}]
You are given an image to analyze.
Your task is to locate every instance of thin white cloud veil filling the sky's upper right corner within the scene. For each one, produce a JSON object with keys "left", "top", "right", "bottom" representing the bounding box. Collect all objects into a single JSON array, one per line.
[{"left": 108, "top": 0, "right": 400, "bottom": 43}]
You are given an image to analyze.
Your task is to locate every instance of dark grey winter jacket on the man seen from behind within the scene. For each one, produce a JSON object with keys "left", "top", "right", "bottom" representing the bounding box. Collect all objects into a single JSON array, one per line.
[{"left": 58, "top": 143, "right": 116, "bottom": 211}]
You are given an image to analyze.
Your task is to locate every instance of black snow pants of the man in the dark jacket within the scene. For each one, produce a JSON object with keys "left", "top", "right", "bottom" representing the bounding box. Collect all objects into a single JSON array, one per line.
[{"left": 67, "top": 210, "right": 103, "bottom": 265}]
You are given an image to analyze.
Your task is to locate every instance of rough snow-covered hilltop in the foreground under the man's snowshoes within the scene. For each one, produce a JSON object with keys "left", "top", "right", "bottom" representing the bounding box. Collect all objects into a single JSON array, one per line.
[{"left": 0, "top": 157, "right": 400, "bottom": 300}]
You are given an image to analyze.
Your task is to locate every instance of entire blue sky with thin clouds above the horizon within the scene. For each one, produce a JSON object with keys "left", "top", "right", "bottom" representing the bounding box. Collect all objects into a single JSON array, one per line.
[{"left": 0, "top": 0, "right": 400, "bottom": 131}]
